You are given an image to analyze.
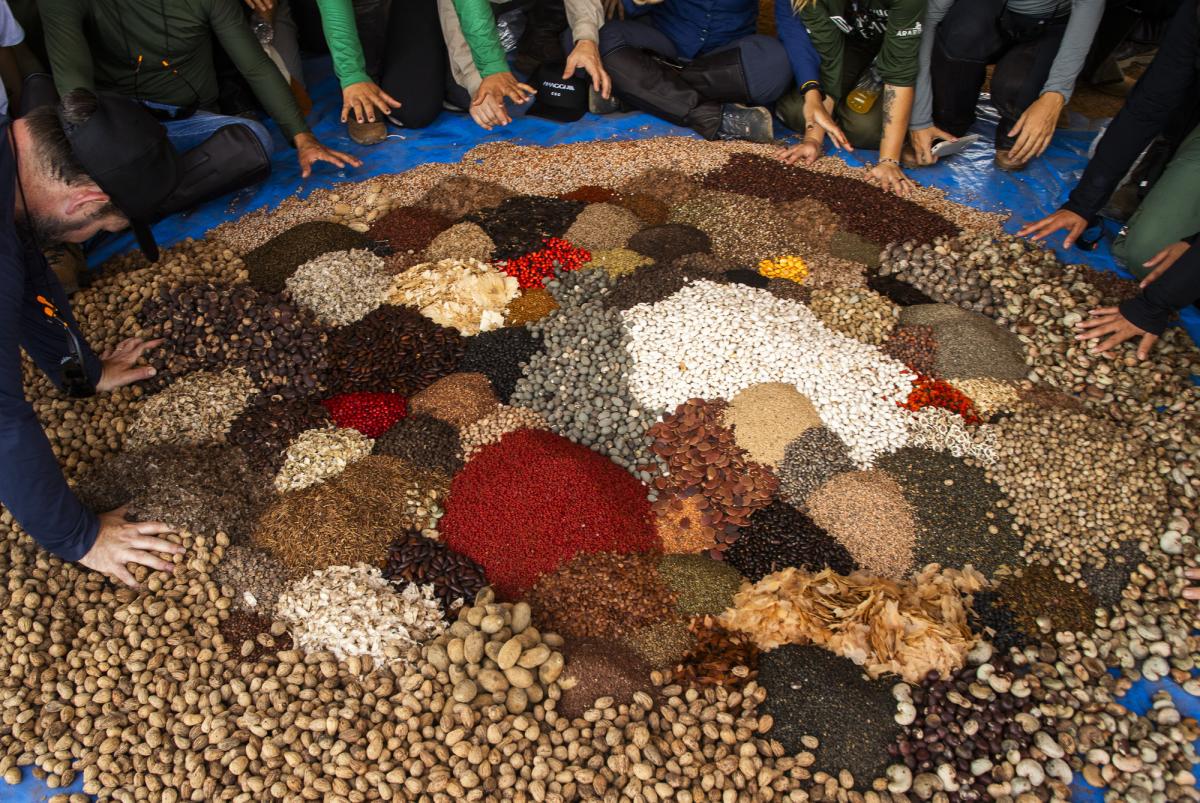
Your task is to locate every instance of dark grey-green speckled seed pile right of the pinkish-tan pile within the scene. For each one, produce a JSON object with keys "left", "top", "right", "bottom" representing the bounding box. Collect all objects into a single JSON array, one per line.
[{"left": 876, "top": 447, "right": 1024, "bottom": 577}]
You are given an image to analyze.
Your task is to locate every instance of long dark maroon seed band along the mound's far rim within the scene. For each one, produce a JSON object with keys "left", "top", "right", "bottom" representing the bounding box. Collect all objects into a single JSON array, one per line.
[{"left": 704, "top": 154, "right": 959, "bottom": 246}]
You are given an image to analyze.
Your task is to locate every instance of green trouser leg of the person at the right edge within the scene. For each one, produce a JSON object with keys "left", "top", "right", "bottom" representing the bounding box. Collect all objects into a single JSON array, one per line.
[{"left": 1112, "top": 126, "right": 1200, "bottom": 278}]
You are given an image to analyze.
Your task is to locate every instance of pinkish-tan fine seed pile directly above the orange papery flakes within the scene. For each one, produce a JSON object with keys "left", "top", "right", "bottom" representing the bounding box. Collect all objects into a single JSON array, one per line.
[{"left": 805, "top": 471, "right": 917, "bottom": 580}]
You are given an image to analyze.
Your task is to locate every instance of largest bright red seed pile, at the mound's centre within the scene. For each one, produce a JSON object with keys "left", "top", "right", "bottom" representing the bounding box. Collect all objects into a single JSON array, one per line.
[{"left": 440, "top": 430, "right": 660, "bottom": 595}]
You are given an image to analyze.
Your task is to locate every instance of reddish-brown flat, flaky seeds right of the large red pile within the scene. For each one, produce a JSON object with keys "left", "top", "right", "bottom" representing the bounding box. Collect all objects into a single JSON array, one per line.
[{"left": 649, "top": 398, "right": 779, "bottom": 551}]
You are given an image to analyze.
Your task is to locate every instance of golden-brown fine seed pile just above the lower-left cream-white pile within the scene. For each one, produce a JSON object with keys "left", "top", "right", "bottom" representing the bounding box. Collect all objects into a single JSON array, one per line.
[{"left": 251, "top": 455, "right": 439, "bottom": 576}]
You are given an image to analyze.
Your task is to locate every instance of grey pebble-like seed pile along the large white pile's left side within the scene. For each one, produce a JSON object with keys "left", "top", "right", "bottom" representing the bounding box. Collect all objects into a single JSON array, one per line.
[{"left": 510, "top": 270, "right": 655, "bottom": 483}]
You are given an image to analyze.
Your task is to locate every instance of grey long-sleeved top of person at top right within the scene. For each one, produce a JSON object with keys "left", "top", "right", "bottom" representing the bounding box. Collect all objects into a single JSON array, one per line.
[{"left": 908, "top": 0, "right": 1104, "bottom": 131}]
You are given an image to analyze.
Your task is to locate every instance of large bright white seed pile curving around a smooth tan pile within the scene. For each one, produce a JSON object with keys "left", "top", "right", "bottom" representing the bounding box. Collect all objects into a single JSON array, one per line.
[{"left": 622, "top": 281, "right": 913, "bottom": 467}]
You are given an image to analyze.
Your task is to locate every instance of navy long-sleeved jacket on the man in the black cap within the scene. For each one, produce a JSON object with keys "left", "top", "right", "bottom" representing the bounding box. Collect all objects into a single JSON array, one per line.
[{"left": 0, "top": 115, "right": 101, "bottom": 561}]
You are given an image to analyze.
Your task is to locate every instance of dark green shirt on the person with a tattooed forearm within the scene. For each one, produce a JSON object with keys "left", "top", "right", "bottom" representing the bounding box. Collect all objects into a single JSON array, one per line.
[{"left": 800, "top": 0, "right": 925, "bottom": 100}]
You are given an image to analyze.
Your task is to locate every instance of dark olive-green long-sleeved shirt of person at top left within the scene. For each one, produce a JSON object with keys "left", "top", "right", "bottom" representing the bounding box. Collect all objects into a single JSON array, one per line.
[{"left": 40, "top": 0, "right": 308, "bottom": 139}]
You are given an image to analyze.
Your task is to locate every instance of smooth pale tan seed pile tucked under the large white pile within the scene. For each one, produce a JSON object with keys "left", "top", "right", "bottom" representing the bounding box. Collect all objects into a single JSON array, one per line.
[{"left": 721, "top": 382, "right": 821, "bottom": 468}]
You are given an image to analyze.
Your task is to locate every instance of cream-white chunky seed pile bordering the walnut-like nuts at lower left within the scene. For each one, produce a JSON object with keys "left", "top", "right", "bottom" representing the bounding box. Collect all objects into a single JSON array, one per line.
[{"left": 276, "top": 563, "right": 446, "bottom": 660}]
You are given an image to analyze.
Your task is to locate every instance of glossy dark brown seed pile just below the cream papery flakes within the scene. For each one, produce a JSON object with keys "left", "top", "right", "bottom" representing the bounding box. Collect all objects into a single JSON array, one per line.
[{"left": 329, "top": 304, "right": 464, "bottom": 396}]
